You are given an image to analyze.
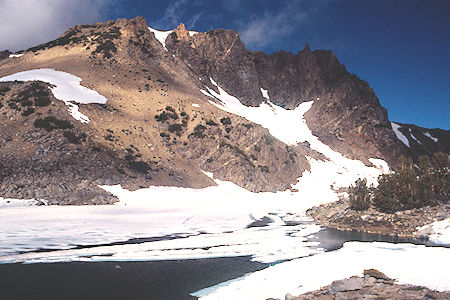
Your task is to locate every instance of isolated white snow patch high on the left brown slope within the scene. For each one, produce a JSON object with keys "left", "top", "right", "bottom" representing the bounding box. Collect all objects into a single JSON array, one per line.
[{"left": 0, "top": 69, "right": 107, "bottom": 123}]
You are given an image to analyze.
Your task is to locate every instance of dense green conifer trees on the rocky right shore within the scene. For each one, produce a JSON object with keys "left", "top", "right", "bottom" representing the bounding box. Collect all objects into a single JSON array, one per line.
[{"left": 349, "top": 152, "right": 450, "bottom": 213}]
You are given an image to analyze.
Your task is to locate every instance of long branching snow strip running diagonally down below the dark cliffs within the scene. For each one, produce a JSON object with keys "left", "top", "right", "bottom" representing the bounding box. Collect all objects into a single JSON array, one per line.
[{"left": 201, "top": 78, "right": 389, "bottom": 190}]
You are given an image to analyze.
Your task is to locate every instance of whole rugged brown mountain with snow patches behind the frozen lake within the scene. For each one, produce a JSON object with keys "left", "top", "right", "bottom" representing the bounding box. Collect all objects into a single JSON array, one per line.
[{"left": 0, "top": 17, "right": 449, "bottom": 204}]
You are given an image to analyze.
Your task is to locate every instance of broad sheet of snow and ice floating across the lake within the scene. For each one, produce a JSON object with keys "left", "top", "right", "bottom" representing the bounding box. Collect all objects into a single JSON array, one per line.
[{"left": 0, "top": 176, "right": 329, "bottom": 263}]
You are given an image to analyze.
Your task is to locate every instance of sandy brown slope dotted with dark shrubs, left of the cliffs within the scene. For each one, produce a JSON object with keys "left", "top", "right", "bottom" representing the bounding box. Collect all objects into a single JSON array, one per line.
[{"left": 0, "top": 18, "right": 320, "bottom": 204}]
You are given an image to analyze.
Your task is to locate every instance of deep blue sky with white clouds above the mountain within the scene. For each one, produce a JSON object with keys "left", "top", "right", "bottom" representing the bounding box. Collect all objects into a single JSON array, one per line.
[{"left": 0, "top": 0, "right": 450, "bottom": 129}]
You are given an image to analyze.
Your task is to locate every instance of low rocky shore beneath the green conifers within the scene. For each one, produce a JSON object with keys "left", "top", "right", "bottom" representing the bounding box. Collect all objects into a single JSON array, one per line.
[{"left": 306, "top": 198, "right": 450, "bottom": 240}]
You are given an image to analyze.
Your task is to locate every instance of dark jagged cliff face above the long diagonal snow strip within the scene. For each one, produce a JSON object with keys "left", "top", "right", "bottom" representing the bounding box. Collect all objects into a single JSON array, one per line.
[{"left": 166, "top": 29, "right": 409, "bottom": 166}]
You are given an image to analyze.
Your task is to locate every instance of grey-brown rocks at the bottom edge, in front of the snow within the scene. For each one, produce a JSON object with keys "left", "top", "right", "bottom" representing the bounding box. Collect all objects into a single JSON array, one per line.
[{"left": 285, "top": 269, "right": 450, "bottom": 300}]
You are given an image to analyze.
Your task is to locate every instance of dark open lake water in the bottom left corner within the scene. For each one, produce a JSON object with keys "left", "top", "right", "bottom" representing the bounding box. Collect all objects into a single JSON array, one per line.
[{"left": 0, "top": 257, "right": 267, "bottom": 300}]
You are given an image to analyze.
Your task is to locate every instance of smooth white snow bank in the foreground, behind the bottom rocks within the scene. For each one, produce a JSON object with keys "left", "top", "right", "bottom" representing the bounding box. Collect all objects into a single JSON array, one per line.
[{"left": 192, "top": 242, "right": 450, "bottom": 300}]
